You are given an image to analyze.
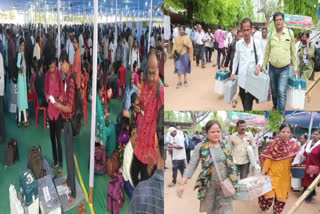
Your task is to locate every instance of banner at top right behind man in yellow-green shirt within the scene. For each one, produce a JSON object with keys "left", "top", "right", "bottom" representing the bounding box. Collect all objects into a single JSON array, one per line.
[{"left": 284, "top": 14, "right": 313, "bottom": 29}]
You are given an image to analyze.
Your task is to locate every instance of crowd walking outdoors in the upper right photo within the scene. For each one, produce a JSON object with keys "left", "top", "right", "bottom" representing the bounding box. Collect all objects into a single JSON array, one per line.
[{"left": 171, "top": 12, "right": 320, "bottom": 111}]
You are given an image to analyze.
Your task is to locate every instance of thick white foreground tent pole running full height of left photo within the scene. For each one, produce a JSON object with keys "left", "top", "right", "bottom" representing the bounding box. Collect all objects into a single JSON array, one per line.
[{"left": 89, "top": 0, "right": 98, "bottom": 206}]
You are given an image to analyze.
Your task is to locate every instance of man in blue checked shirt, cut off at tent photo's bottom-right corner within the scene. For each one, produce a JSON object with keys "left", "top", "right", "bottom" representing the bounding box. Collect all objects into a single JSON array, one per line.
[{"left": 129, "top": 110, "right": 164, "bottom": 214}]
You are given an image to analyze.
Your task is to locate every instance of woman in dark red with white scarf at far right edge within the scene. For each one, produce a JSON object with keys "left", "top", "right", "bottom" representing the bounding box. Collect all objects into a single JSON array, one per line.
[{"left": 302, "top": 130, "right": 320, "bottom": 202}]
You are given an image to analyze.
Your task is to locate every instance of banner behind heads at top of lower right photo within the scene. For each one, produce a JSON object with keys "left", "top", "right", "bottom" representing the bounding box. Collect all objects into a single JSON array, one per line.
[{"left": 228, "top": 111, "right": 266, "bottom": 129}]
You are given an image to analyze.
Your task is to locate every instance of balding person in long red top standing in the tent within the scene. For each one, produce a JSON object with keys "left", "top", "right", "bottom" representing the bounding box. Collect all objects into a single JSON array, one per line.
[{"left": 130, "top": 51, "right": 164, "bottom": 186}]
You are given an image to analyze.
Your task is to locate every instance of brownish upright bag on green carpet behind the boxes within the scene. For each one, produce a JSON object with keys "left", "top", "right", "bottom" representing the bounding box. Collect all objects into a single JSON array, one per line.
[{"left": 28, "top": 145, "right": 45, "bottom": 179}]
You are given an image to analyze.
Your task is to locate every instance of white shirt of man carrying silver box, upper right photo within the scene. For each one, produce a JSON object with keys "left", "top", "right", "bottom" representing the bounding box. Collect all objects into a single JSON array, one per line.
[{"left": 232, "top": 37, "right": 263, "bottom": 89}]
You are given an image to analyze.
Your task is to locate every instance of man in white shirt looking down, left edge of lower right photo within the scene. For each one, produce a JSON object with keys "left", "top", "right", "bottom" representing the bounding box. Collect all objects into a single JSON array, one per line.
[{"left": 168, "top": 127, "right": 186, "bottom": 187}]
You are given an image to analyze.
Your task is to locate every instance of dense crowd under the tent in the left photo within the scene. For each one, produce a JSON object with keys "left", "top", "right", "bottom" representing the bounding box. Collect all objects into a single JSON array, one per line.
[{"left": 0, "top": 22, "right": 166, "bottom": 213}]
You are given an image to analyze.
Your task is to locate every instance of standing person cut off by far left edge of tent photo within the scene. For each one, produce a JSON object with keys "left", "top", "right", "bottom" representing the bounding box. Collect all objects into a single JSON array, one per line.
[{"left": 0, "top": 53, "right": 6, "bottom": 143}]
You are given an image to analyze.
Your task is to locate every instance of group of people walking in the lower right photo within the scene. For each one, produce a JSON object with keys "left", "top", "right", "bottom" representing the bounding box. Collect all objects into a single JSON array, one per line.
[{"left": 165, "top": 120, "right": 320, "bottom": 214}]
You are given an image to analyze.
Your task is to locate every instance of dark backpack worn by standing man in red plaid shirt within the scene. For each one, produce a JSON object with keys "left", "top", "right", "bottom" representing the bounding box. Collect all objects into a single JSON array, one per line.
[{"left": 68, "top": 73, "right": 84, "bottom": 136}]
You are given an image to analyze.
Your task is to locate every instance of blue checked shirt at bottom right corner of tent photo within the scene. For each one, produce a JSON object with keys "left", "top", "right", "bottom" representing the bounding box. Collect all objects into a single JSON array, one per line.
[{"left": 130, "top": 170, "right": 164, "bottom": 214}]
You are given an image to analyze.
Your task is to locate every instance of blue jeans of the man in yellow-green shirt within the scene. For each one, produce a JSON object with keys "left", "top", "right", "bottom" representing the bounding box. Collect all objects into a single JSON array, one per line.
[{"left": 269, "top": 63, "right": 289, "bottom": 111}]
